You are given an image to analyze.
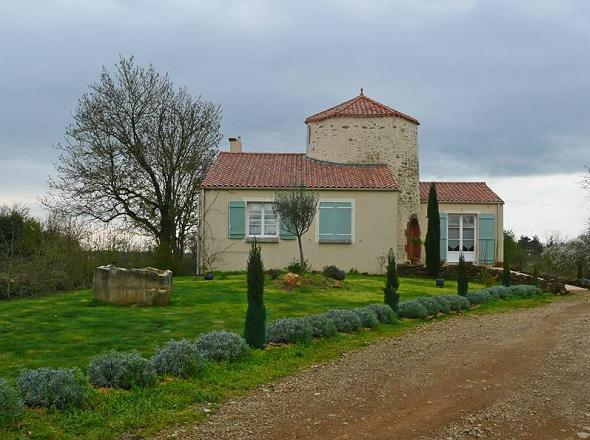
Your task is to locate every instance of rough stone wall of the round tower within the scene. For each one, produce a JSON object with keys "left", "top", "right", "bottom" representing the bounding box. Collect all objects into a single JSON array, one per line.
[{"left": 307, "top": 117, "right": 425, "bottom": 262}]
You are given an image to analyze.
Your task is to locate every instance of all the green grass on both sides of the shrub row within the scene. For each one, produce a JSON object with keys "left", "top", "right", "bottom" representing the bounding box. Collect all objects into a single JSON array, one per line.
[{"left": 0, "top": 275, "right": 564, "bottom": 439}]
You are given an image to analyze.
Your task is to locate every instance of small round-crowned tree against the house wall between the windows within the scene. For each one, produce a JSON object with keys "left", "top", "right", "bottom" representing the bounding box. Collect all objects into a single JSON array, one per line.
[{"left": 274, "top": 185, "right": 318, "bottom": 272}]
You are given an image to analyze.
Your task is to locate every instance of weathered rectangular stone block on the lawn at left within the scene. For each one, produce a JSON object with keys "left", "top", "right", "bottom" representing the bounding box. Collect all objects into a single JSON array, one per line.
[{"left": 93, "top": 265, "right": 172, "bottom": 306}]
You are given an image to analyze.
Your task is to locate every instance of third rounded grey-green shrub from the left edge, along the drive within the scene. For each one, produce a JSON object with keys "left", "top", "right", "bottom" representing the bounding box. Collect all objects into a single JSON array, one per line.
[{"left": 88, "top": 350, "right": 158, "bottom": 390}]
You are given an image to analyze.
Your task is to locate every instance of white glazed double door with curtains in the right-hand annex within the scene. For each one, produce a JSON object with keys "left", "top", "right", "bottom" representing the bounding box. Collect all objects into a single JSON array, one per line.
[{"left": 447, "top": 214, "right": 476, "bottom": 263}]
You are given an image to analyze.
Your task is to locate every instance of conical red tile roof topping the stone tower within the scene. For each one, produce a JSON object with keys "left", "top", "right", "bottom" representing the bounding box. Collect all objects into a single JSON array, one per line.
[{"left": 305, "top": 89, "right": 420, "bottom": 125}]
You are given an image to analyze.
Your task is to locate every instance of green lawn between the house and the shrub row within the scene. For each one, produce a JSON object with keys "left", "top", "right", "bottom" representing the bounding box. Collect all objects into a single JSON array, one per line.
[{"left": 0, "top": 274, "right": 477, "bottom": 379}]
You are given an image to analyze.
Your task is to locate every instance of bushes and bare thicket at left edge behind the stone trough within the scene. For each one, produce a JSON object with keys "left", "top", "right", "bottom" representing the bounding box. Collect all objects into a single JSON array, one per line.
[{"left": 0, "top": 206, "right": 195, "bottom": 299}]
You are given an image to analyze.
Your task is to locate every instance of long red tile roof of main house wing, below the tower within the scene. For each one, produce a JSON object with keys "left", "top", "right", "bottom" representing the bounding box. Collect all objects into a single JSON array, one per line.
[{"left": 202, "top": 152, "right": 398, "bottom": 190}]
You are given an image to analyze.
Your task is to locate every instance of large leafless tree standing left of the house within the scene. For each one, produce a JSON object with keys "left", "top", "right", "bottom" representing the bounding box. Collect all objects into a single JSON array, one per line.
[{"left": 44, "top": 58, "right": 221, "bottom": 266}]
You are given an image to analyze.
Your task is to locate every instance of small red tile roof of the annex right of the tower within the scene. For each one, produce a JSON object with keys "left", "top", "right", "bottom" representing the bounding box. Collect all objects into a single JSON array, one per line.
[{"left": 420, "top": 182, "right": 504, "bottom": 203}]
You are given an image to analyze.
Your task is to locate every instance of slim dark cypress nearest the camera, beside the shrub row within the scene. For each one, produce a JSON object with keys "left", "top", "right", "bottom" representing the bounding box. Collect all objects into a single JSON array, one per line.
[{"left": 244, "top": 241, "right": 266, "bottom": 348}]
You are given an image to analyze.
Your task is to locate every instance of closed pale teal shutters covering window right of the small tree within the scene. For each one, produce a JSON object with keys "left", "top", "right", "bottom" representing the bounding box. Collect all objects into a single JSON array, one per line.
[{"left": 319, "top": 202, "right": 352, "bottom": 243}]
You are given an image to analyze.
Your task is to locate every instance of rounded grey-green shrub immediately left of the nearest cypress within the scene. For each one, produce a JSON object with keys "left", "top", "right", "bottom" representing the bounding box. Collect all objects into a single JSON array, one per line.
[{"left": 195, "top": 330, "right": 248, "bottom": 362}]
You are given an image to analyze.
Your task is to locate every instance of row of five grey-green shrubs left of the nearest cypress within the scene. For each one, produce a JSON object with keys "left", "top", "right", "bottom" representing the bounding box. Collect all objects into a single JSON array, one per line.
[{"left": 0, "top": 331, "right": 249, "bottom": 425}]
